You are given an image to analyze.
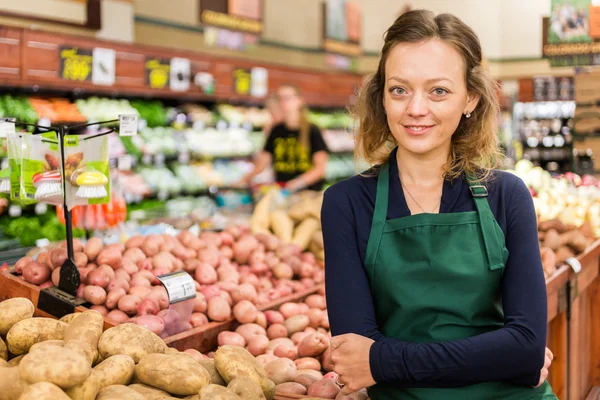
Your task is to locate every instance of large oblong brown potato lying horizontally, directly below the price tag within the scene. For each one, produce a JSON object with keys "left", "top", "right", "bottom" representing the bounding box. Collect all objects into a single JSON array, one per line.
[{"left": 135, "top": 354, "right": 210, "bottom": 396}]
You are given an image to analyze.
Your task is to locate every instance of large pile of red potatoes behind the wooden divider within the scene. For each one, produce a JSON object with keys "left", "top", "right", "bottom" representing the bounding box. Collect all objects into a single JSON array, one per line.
[{"left": 10, "top": 226, "right": 325, "bottom": 335}]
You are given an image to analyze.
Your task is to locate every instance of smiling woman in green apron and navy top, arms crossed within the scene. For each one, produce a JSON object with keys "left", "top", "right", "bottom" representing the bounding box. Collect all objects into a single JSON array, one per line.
[{"left": 322, "top": 10, "right": 556, "bottom": 400}]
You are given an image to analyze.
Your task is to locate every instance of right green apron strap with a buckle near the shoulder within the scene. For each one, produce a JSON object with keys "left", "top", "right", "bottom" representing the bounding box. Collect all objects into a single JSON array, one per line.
[{"left": 467, "top": 177, "right": 504, "bottom": 270}]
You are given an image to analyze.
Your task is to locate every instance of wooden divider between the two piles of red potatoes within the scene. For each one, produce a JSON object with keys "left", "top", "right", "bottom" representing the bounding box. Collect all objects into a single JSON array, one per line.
[{"left": 164, "top": 285, "right": 322, "bottom": 353}]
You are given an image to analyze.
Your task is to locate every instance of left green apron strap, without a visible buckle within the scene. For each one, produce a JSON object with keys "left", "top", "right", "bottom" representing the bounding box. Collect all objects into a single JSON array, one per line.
[{"left": 365, "top": 161, "right": 390, "bottom": 271}]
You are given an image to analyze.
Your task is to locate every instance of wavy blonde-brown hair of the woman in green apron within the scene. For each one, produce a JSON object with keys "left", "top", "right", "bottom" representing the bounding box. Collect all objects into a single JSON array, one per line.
[{"left": 350, "top": 10, "right": 504, "bottom": 181}]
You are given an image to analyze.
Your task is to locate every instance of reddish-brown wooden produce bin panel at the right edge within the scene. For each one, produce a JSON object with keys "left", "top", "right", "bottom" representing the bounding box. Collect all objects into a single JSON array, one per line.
[{"left": 560, "top": 240, "right": 600, "bottom": 400}]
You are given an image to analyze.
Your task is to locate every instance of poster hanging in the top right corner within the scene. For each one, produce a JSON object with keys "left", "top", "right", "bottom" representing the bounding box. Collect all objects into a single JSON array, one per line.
[{"left": 542, "top": 0, "right": 600, "bottom": 67}]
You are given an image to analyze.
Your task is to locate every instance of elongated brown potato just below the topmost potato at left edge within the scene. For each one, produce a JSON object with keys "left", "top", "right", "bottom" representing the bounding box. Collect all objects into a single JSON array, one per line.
[{"left": 6, "top": 318, "right": 68, "bottom": 355}]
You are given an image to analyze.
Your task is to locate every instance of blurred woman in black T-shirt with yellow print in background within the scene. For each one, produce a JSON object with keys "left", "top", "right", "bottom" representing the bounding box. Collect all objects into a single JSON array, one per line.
[{"left": 240, "top": 85, "right": 328, "bottom": 191}]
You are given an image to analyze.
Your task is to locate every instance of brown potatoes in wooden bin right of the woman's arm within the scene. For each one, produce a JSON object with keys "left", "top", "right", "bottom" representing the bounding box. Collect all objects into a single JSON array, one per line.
[{"left": 538, "top": 219, "right": 597, "bottom": 279}]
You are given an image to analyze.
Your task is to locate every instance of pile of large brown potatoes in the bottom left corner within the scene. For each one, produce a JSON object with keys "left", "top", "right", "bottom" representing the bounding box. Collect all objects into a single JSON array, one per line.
[{"left": 0, "top": 298, "right": 282, "bottom": 400}]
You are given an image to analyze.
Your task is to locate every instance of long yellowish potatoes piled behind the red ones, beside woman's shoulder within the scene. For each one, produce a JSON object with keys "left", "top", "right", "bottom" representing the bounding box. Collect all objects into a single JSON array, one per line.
[{"left": 250, "top": 190, "right": 325, "bottom": 261}]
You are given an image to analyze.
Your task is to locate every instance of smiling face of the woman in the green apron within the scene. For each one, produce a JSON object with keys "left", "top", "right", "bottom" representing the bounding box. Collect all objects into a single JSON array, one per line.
[{"left": 383, "top": 39, "right": 479, "bottom": 156}]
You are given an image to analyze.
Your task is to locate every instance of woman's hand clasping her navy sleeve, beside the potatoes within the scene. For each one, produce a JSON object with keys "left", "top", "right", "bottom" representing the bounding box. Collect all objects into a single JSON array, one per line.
[{"left": 330, "top": 333, "right": 377, "bottom": 394}]
